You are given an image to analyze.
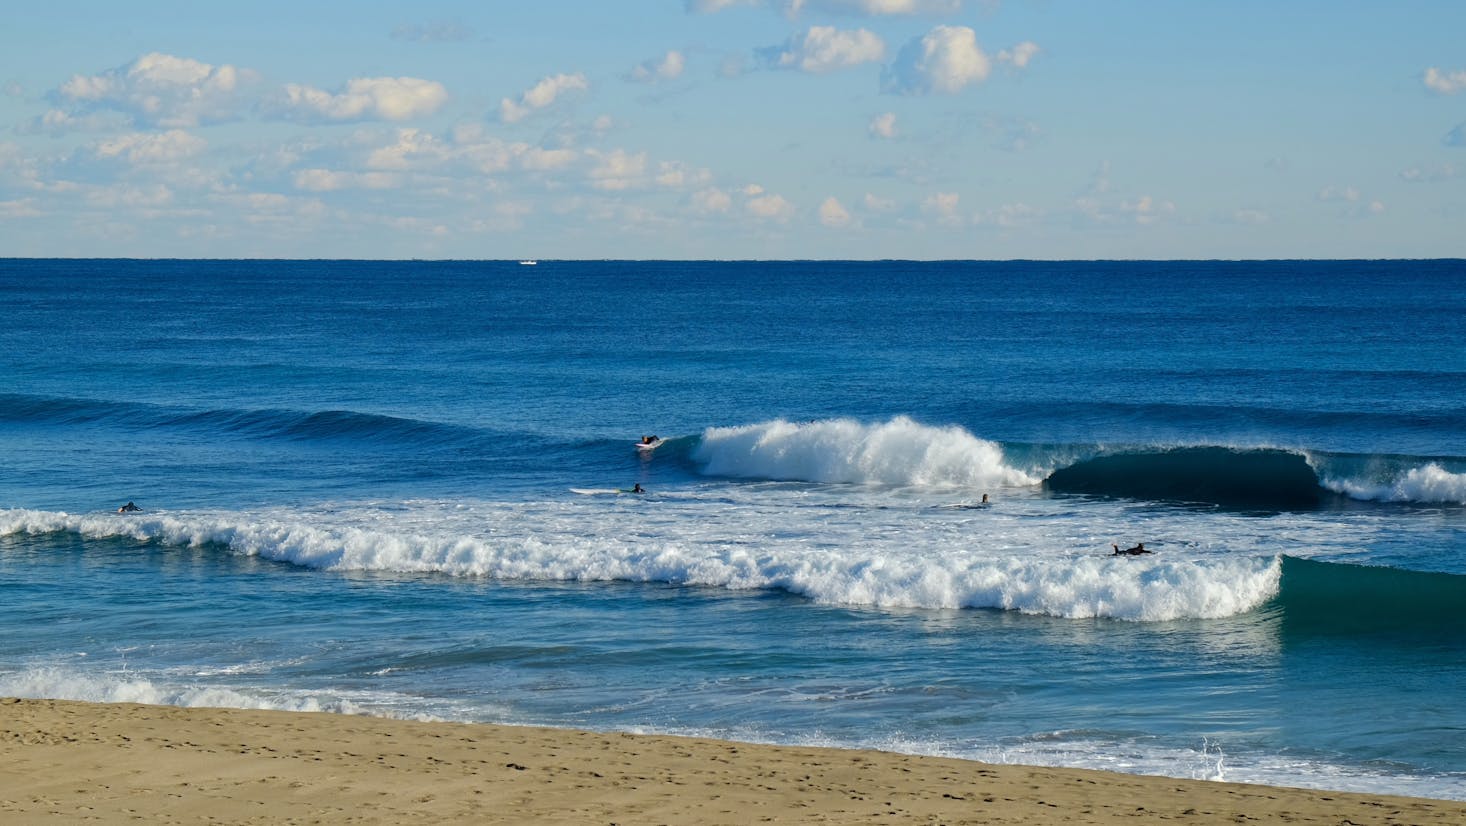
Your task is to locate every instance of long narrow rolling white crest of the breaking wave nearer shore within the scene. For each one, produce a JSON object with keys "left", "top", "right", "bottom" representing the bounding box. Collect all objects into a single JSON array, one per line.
[{"left": 0, "top": 511, "right": 1281, "bottom": 622}]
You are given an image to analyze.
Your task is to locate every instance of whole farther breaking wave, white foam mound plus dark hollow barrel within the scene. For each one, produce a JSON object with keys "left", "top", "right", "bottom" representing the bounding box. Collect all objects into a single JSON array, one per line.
[{"left": 690, "top": 417, "right": 1466, "bottom": 511}]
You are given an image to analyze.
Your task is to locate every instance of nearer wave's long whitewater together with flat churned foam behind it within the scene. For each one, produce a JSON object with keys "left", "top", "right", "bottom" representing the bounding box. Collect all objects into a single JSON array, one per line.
[{"left": 0, "top": 499, "right": 1281, "bottom": 621}]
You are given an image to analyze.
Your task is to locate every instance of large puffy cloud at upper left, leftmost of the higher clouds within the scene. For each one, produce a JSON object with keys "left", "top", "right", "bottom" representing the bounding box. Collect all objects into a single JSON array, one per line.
[{"left": 54, "top": 51, "right": 258, "bottom": 128}]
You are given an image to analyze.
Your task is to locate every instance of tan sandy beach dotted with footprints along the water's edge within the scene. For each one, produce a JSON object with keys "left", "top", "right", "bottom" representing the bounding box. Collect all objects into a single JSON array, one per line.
[{"left": 0, "top": 700, "right": 1466, "bottom": 826}]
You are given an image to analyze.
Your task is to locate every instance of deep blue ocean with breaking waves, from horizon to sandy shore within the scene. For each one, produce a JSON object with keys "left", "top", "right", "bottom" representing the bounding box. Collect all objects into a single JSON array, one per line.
[{"left": 0, "top": 260, "right": 1466, "bottom": 800}]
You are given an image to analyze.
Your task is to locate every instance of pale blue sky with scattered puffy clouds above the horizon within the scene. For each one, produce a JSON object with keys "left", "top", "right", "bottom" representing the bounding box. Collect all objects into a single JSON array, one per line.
[{"left": 0, "top": 0, "right": 1466, "bottom": 258}]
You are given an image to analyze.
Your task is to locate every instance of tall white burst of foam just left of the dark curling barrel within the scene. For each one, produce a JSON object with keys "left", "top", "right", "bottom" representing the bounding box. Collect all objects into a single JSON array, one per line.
[{"left": 693, "top": 417, "right": 1038, "bottom": 487}]
